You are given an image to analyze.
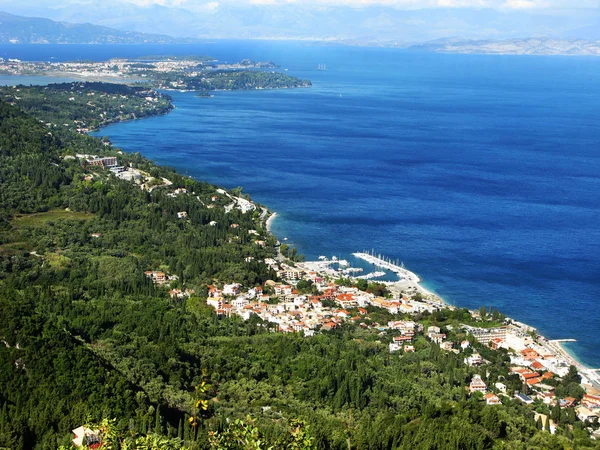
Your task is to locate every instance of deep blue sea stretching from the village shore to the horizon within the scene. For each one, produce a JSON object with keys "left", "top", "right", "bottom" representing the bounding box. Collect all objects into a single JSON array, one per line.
[{"left": 0, "top": 41, "right": 600, "bottom": 367}]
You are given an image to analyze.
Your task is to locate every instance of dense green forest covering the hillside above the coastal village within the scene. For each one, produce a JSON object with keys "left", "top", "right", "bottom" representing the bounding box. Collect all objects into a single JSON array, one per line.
[{"left": 0, "top": 86, "right": 600, "bottom": 450}]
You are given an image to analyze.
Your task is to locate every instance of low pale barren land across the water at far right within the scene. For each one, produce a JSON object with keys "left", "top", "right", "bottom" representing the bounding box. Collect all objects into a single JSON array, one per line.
[{"left": 410, "top": 38, "right": 600, "bottom": 56}]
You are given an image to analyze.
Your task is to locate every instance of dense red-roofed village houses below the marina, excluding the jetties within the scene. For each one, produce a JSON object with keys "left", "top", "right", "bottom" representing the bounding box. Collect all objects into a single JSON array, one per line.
[{"left": 178, "top": 253, "right": 600, "bottom": 439}]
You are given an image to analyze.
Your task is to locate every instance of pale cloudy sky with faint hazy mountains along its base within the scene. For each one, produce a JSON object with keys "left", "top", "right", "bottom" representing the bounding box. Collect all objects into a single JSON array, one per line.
[{"left": 0, "top": 0, "right": 600, "bottom": 42}]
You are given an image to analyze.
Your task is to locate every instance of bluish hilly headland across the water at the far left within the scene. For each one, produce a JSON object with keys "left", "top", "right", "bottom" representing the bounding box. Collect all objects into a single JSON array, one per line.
[{"left": 0, "top": 12, "right": 192, "bottom": 44}]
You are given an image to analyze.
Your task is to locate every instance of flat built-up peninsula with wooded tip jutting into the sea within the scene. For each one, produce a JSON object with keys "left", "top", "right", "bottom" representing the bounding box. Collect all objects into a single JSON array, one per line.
[{"left": 0, "top": 56, "right": 312, "bottom": 92}]
